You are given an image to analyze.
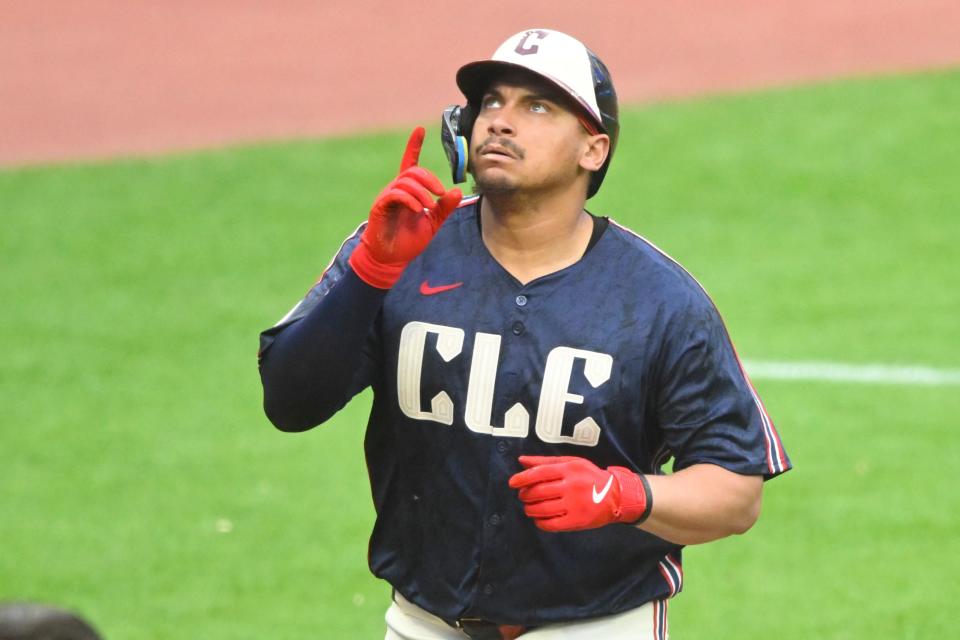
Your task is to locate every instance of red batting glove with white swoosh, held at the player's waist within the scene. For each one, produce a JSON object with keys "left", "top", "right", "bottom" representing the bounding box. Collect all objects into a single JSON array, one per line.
[{"left": 510, "top": 456, "right": 653, "bottom": 531}]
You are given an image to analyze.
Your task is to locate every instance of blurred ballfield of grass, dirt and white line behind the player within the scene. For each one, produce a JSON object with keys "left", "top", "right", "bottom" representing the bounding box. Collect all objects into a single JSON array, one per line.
[{"left": 0, "top": 0, "right": 960, "bottom": 640}]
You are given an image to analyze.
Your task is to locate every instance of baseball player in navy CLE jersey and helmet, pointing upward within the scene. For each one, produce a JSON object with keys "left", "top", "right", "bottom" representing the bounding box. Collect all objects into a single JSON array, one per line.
[{"left": 260, "top": 29, "right": 791, "bottom": 640}]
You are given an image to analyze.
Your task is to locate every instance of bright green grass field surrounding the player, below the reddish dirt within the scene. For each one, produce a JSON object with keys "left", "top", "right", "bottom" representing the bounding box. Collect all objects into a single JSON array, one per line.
[{"left": 0, "top": 71, "right": 960, "bottom": 640}]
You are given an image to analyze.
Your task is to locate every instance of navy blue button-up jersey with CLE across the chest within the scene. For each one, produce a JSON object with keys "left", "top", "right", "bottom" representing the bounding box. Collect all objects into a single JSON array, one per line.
[{"left": 261, "top": 198, "right": 790, "bottom": 625}]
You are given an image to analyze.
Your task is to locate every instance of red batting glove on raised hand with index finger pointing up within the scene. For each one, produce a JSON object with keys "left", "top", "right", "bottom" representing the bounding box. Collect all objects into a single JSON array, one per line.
[{"left": 350, "top": 127, "right": 462, "bottom": 289}]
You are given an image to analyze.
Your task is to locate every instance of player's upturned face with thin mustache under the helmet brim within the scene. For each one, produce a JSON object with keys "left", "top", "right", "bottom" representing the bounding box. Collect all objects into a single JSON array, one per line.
[{"left": 470, "top": 75, "right": 606, "bottom": 194}]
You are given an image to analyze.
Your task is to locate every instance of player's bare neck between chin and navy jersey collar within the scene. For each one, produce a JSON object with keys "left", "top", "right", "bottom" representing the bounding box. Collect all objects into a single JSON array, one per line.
[{"left": 480, "top": 189, "right": 593, "bottom": 284}]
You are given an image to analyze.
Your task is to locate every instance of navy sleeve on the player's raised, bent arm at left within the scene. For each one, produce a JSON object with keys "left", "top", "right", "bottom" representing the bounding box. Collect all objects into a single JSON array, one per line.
[{"left": 258, "top": 224, "right": 386, "bottom": 431}]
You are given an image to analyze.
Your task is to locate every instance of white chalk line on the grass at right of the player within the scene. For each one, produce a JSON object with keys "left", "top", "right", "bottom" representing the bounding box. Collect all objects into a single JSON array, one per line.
[{"left": 743, "top": 360, "right": 960, "bottom": 386}]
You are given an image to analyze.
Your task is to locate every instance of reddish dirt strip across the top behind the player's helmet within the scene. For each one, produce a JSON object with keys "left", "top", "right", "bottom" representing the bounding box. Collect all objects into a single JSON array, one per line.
[{"left": 0, "top": 0, "right": 960, "bottom": 165}]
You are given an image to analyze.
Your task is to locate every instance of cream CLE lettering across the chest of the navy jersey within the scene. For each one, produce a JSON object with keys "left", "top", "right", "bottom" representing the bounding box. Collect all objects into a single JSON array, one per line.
[{"left": 397, "top": 321, "right": 613, "bottom": 447}]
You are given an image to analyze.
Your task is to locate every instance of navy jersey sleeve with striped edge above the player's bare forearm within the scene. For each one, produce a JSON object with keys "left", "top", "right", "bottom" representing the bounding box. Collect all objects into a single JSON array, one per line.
[{"left": 657, "top": 294, "right": 792, "bottom": 479}]
